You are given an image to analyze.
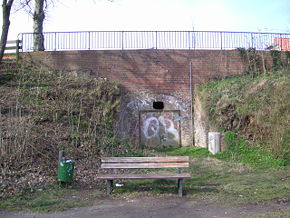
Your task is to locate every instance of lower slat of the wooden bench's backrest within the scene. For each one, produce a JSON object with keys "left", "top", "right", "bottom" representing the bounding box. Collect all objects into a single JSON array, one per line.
[{"left": 101, "top": 163, "right": 189, "bottom": 169}]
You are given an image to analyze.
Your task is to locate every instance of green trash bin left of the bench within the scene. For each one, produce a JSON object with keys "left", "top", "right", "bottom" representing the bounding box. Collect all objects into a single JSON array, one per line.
[{"left": 57, "top": 160, "right": 75, "bottom": 182}]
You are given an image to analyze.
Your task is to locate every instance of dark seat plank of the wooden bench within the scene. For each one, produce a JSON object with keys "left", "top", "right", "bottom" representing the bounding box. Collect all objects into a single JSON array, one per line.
[{"left": 97, "top": 173, "right": 190, "bottom": 180}]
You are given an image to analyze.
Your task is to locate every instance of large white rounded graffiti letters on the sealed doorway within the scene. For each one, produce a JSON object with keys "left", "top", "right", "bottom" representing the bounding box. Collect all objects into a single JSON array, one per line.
[{"left": 142, "top": 116, "right": 179, "bottom": 142}]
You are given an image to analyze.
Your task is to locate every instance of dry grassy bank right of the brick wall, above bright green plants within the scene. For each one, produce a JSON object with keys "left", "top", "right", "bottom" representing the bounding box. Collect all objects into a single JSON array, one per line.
[{"left": 197, "top": 71, "right": 290, "bottom": 163}]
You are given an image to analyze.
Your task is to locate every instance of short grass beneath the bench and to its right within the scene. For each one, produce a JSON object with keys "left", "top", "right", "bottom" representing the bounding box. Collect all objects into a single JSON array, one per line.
[{"left": 109, "top": 148, "right": 290, "bottom": 205}]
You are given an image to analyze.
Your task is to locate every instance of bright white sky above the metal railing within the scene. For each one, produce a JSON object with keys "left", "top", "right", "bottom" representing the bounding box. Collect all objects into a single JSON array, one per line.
[{"left": 0, "top": 0, "right": 290, "bottom": 40}]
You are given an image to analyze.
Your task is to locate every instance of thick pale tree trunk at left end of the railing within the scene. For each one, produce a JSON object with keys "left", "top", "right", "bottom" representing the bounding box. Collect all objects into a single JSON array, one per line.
[{"left": 33, "top": 0, "right": 45, "bottom": 51}]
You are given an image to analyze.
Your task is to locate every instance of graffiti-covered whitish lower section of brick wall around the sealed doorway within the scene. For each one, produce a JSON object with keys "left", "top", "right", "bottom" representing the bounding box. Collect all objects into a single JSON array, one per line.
[{"left": 117, "top": 91, "right": 192, "bottom": 147}]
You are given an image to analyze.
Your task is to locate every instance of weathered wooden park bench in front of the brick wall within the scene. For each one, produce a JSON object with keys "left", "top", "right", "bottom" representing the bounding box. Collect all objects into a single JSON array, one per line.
[{"left": 97, "top": 157, "right": 191, "bottom": 196}]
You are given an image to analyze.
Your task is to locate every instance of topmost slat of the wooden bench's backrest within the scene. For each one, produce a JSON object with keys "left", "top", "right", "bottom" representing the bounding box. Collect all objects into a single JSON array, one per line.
[{"left": 102, "top": 157, "right": 189, "bottom": 163}]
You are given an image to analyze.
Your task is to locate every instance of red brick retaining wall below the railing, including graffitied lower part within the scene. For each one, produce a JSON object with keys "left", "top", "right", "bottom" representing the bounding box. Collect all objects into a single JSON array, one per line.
[{"left": 20, "top": 49, "right": 284, "bottom": 146}]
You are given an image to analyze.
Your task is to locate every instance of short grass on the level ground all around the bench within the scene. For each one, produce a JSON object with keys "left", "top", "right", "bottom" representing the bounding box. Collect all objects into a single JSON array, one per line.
[{"left": 0, "top": 148, "right": 290, "bottom": 212}]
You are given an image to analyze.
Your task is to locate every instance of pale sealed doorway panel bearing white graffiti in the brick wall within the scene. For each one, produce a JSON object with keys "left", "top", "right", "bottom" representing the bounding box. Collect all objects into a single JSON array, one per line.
[{"left": 140, "top": 111, "right": 180, "bottom": 147}]
